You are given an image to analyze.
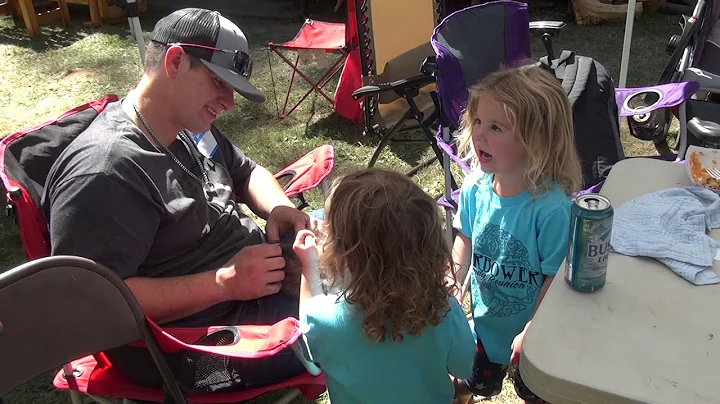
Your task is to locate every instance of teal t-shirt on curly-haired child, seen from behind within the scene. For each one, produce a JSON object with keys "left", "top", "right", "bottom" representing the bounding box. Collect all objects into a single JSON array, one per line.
[{"left": 301, "top": 295, "right": 476, "bottom": 404}]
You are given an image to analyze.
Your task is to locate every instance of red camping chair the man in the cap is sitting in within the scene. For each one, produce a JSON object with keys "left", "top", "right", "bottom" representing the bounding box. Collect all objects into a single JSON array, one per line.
[{"left": 0, "top": 95, "right": 334, "bottom": 403}]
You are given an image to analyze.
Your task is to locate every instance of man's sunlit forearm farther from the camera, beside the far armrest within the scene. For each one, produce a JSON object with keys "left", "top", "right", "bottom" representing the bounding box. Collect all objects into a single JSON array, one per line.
[{"left": 241, "top": 166, "right": 295, "bottom": 219}]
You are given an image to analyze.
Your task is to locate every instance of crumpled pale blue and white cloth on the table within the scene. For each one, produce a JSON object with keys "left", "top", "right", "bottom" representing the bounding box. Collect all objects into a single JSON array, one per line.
[{"left": 610, "top": 186, "right": 720, "bottom": 285}]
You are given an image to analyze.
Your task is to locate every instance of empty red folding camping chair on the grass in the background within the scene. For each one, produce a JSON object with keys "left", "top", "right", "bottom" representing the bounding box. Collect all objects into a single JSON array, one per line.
[{"left": 267, "top": 3, "right": 359, "bottom": 118}]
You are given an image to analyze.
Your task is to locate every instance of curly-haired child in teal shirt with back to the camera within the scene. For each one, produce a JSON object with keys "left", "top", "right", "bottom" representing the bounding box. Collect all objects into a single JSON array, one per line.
[{"left": 294, "top": 169, "right": 475, "bottom": 403}]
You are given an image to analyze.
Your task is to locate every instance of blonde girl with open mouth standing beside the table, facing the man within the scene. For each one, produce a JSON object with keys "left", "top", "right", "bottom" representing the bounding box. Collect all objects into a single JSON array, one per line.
[{"left": 453, "top": 67, "right": 582, "bottom": 403}]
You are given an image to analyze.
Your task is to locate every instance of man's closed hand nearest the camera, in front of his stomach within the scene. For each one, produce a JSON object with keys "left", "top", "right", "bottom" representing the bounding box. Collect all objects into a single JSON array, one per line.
[{"left": 215, "top": 244, "right": 285, "bottom": 300}]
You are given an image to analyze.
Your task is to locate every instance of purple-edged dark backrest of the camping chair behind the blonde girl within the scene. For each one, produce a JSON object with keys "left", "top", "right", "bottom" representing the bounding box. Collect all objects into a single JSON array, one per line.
[{"left": 431, "top": 1, "right": 530, "bottom": 126}]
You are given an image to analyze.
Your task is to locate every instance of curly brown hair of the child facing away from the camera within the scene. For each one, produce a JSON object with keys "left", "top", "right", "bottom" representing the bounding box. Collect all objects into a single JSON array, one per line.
[{"left": 320, "top": 169, "right": 453, "bottom": 343}]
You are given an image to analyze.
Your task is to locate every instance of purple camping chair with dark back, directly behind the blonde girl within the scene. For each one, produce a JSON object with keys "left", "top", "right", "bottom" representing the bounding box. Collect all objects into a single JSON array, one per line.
[{"left": 423, "top": 0, "right": 530, "bottom": 242}]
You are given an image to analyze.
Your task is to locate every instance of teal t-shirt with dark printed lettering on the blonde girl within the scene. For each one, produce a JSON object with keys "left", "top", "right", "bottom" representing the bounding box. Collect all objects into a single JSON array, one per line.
[{"left": 454, "top": 172, "right": 571, "bottom": 365}]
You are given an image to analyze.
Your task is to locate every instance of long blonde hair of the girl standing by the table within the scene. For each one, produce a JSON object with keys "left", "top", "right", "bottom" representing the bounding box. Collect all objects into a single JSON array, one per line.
[{"left": 458, "top": 66, "right": 582, "bottom": 196}]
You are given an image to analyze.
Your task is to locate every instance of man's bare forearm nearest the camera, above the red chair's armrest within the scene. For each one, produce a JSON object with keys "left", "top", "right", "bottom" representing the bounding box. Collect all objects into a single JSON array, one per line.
[{"left": 125, "top": 271, "right": 228, "bottom": 324}]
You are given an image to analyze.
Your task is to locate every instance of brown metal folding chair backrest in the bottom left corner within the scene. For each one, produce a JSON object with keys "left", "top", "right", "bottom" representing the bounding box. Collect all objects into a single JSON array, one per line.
[{"left": 0, "top": 257, "right": 144, "bottom": 397}]
